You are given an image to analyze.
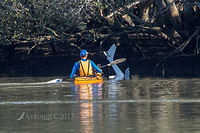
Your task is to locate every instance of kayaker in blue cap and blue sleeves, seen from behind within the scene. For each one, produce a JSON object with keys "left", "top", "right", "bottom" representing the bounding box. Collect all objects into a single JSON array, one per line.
[{"left": 70, "top": 49, "right": 102, "bottom": 78}]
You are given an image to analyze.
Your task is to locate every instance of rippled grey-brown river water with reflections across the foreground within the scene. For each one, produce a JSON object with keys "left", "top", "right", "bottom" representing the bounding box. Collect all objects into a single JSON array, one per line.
[{"left": 0, "top": 77, "right": 200, "bottom": 133}]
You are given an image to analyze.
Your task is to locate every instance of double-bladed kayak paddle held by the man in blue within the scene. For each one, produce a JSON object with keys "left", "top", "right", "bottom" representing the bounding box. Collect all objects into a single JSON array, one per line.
[{"left": 47, "top": 58, "right": 126, "bottom": 83}]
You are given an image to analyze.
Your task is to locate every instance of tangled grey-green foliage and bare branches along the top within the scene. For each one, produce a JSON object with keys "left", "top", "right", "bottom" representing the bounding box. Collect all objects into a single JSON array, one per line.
[{"left": 0, "top": 0, "right": 200, "bottom": 54}]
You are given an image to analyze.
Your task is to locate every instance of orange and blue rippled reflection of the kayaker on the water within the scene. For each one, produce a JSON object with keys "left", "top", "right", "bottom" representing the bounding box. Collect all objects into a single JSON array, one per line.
[{"left": 71, "top": 83, "right": 103, "bottom": 133}]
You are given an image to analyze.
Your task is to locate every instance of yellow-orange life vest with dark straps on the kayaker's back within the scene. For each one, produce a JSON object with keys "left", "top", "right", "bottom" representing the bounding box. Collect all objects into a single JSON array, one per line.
[{"left": 79, "top": 60, "right": 93, "bottom": 76}]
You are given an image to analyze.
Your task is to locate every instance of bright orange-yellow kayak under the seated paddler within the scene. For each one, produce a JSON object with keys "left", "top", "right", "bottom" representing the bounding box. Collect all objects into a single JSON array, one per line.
[{"left": 74, "top": 76, "right": 103, "bottom": 84}]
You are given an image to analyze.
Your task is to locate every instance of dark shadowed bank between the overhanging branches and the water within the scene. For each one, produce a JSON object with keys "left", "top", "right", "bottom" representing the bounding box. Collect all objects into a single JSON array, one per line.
[{"left": 0, "top": 36, "right": 200, "bottom": 77}]
